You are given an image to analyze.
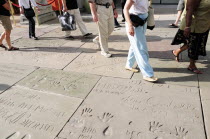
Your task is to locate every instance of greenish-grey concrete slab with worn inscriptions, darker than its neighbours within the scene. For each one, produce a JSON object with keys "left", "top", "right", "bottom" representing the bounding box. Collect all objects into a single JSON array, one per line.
[{"left": 18, "top": 69, "right": 100, "bottom": 98}]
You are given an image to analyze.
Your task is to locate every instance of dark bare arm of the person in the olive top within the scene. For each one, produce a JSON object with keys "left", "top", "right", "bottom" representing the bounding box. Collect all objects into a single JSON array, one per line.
[{"left": 184, "top": 0, "right": 201, "bottom": 37}]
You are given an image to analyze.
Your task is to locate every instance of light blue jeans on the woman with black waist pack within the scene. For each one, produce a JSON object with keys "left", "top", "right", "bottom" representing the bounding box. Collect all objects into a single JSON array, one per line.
[{"left": 126, "top": 13, "right": 154, "bottom": 77}]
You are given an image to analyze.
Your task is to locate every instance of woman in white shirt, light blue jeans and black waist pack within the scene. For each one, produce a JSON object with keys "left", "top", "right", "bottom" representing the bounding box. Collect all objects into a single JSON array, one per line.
[{"left": 124, "top": 0, "right": 158, "bottom": 82}]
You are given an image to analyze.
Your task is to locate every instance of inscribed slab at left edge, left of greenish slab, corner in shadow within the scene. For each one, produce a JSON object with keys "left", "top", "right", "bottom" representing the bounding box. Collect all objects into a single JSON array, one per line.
[{"left": 0, "top": 63, "right": 36, "bottom": 93}]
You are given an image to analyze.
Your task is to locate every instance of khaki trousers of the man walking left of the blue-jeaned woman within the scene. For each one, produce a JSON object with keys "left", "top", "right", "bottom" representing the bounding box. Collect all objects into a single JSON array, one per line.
[{"left": 97, "top": 5, "right": 114, "bottom": 52}]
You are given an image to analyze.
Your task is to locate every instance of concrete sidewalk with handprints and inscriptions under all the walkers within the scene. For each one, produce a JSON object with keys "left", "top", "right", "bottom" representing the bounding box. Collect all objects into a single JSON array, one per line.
[{"left": 0, "top": 5, "right": 210, "bottom": 139}]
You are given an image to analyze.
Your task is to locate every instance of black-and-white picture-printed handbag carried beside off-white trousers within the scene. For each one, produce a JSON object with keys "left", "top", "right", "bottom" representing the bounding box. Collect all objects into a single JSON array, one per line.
[{"left": 58, "top": 12, "right": 77, "bottom": 31}]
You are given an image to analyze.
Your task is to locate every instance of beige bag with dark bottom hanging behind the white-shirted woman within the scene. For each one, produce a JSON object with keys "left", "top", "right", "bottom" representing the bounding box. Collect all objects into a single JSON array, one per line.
[{"left": 147, "top": 0, "right": 155, "bottom": 30}]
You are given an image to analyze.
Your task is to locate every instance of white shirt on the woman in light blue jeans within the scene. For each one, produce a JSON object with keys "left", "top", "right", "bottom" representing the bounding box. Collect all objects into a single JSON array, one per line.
[{"left": 129, "top": 0, "right": 149, "bottom": 15}]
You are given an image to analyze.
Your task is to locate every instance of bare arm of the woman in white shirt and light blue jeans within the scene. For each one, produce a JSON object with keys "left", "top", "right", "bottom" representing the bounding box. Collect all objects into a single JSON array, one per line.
[{"left": 123, "top": 0, "right": 134, "bottom": 36}]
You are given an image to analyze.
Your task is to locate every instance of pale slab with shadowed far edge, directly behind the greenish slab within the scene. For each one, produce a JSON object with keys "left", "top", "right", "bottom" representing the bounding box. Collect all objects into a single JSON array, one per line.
[{"left": 0, "top": 45, "right": 81, "bottom": 69}]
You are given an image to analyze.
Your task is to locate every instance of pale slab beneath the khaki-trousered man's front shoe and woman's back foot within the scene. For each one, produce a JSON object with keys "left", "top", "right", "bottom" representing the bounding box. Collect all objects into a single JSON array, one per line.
[{"left": 64, "top": 52, "right": 132, "bottom": 78}]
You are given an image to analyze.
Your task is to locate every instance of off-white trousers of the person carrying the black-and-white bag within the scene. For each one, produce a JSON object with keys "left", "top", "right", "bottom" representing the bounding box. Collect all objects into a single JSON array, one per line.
[{"left": 65, "top": 8, "right": 88, "bottom": 37}]
